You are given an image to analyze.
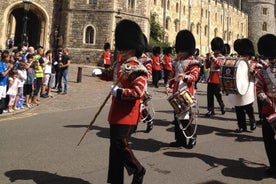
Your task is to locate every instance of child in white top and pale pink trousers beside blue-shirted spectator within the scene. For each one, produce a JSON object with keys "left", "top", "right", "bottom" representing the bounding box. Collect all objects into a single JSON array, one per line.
[{"left": 7, "top": 70, "right": 19, "bottom": 112}]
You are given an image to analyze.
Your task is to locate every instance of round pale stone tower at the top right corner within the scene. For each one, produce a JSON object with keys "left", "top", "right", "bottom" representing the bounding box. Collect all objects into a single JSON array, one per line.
[{"left": 242, "top": 0, "right": 276, "bottom": 46}]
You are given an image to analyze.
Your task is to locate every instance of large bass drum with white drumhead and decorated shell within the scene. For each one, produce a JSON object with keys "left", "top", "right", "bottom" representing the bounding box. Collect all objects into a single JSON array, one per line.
[{"left": 220, "top": 58, "right": 249, "bottom": 95}]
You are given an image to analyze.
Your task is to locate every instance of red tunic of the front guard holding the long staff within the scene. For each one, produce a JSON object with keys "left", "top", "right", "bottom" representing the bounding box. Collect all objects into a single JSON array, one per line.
[{"left": 108, "top": 57, "right": 148, "bottom": 125}]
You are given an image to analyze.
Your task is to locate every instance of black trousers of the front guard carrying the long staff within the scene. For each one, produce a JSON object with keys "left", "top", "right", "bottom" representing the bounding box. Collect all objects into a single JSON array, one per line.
[{"left": 107, "top": 125, "right": 142, "bottom": 184}]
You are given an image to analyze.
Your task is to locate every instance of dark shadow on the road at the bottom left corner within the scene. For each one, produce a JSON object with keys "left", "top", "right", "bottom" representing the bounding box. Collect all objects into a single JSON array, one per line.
[{"left": 5, "top": 170, "right": 89, "bottom": 184}]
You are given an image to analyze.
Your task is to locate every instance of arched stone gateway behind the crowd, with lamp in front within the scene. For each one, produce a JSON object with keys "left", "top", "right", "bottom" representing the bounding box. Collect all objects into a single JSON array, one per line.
[{"left": 4, "top": 3, "right": 50, "bottom": 47}]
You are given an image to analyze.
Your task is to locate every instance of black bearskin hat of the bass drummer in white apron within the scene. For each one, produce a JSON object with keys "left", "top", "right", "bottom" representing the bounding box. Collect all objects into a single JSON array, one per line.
[{"left": 237, "top": 38, "right": 255, "bottom": 56}]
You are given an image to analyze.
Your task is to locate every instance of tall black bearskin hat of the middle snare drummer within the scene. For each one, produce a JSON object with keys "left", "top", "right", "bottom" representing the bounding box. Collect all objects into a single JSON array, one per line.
[{"left": 175, "top": 30, "right": 196, "bottom": 55}]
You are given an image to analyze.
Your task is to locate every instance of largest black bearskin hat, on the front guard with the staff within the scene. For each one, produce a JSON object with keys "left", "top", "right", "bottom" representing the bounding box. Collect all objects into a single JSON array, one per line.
[{"left": 115, "top": 19, "right": 145, "bottom": 57}]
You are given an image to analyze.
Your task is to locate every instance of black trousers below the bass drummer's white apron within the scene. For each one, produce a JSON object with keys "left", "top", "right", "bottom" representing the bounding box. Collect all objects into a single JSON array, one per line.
[{"left": 235, "top": 103, "right": 255, "bottom": 129}]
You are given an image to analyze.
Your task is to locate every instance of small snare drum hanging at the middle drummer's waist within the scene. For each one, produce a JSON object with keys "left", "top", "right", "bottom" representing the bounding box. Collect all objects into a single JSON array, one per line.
[{"left": 168, "top": 89, "right": 194, "bottom": 114}]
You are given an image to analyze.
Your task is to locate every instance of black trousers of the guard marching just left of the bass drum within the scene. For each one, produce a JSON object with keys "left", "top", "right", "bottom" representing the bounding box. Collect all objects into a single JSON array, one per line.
[{"left": 207, "top": 83, "right": 224, "bottom": 111}]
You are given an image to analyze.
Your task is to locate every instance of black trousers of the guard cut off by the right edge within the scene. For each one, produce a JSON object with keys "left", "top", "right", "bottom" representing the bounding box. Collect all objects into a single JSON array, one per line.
[{"left": 262, "top": 118, "right": 276, "bottom": 169}]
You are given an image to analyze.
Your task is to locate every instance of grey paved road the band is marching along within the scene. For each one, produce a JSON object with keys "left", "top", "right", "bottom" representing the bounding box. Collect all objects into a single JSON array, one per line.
[{"left": 0, "top": 65, "right": 275, "bottom": 184}]
